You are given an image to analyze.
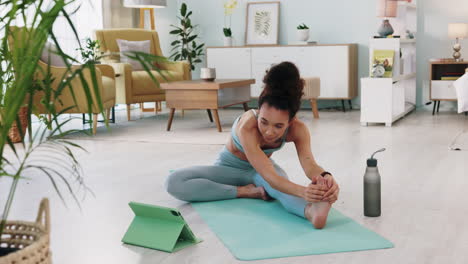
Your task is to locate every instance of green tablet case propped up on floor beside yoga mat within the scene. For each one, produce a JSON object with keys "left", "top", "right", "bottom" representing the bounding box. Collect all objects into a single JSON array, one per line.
[{"left": 122, "top": 202, "right": 202, "bottom": 252}]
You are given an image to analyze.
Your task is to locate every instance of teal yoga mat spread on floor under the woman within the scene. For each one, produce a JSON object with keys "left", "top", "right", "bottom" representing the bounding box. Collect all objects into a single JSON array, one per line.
[{"left": 192, "top": 199, "right": 393, "bottom": 260}]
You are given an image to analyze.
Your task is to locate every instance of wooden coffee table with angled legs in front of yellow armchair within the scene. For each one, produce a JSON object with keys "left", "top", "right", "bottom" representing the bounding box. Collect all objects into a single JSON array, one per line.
[{"left": 161, "top": 79, "right": 255, "bottom": 132}]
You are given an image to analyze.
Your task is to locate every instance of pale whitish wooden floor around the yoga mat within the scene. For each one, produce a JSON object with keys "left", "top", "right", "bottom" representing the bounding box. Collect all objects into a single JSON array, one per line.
[{"left": 0, "top": 106, "right": 468, "bottom": 264}]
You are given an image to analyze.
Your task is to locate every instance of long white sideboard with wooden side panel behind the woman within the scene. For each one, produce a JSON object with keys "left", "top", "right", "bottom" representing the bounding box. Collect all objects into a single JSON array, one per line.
[{"left": 206, "top": 44, "right": 358, "bottom": 100}]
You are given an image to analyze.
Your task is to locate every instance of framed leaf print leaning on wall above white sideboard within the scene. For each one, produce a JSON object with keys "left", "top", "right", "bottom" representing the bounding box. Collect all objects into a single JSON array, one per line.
[{"left": 245, "top": 1, "right": 280, "bottom": 45}]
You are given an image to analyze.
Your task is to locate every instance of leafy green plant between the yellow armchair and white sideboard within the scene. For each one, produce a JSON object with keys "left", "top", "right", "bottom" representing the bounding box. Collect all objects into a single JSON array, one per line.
[{"left": 169, "top": 3, "right": 205, "bottom": 71}]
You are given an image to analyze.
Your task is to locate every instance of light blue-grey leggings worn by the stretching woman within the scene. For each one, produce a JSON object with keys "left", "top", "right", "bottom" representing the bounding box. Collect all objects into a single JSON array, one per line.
[{"left": 166, "top": 147, "right": 307, "bottom": 217}]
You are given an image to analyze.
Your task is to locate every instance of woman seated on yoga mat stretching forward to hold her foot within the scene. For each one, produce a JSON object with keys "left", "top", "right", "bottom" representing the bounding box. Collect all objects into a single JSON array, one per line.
[{"left": 166, "top": 62, "right": 339, "bottom": 228}]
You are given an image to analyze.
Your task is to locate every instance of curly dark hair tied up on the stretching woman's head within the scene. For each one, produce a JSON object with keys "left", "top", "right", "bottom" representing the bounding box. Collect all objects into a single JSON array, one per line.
[{"left": 258, "top": 61, "right": 304, "bottom": 120}]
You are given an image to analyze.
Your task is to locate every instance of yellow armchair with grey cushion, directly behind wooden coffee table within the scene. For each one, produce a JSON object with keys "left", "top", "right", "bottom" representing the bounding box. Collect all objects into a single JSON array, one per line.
[{"left": 95, "top": 29, "right": 191, "bottom": 121}]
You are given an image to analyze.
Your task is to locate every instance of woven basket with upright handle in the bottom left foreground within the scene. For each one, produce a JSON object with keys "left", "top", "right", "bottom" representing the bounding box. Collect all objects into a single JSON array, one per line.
[{"left": 0, "top": 198, "right": 52, "bottom": 264}]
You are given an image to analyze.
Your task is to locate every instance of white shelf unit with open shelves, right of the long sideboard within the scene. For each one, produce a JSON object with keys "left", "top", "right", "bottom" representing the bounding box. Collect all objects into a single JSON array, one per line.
[{"left": 361, "top": 2, "right": 417, "bottom": 126}]
